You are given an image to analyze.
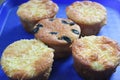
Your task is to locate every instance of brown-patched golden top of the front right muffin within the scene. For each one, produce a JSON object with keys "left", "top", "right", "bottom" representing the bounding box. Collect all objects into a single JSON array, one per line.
[{"left": 72, "top": 36, "right": 120, "bottom": 71}]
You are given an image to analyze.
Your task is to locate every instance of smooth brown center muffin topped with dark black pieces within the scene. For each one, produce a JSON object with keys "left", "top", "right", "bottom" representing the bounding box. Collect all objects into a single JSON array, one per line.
[{"left": 32, "top": 18, "right": 81, "bottom": 59}]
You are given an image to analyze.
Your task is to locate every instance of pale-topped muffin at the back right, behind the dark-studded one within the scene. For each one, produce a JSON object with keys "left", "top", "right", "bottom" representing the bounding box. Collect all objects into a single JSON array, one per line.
[{"left": 66, "top": 1, "right": 107, "bottom": 36}]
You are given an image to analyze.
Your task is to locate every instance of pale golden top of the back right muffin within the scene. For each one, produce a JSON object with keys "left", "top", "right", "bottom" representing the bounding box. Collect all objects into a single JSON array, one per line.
[{"left": 66, "top": 1, "right": 107, "bottom": 25}]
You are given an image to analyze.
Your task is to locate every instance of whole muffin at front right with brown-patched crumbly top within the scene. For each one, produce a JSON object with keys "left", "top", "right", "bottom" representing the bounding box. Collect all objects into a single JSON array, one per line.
[{"left": 72, "top": 36, "right": 120, "bottom": 80}]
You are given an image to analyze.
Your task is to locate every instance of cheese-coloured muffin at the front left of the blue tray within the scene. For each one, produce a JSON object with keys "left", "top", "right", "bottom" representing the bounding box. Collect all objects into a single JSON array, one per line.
[{"left": 1, "top": 39, "right": 54, "bottom": 80}]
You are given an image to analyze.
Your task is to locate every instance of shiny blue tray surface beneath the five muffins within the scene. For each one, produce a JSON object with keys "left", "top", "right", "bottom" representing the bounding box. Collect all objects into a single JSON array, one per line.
[{"left": 0, "top": 0, "right": 120, "bottom": 80}]
